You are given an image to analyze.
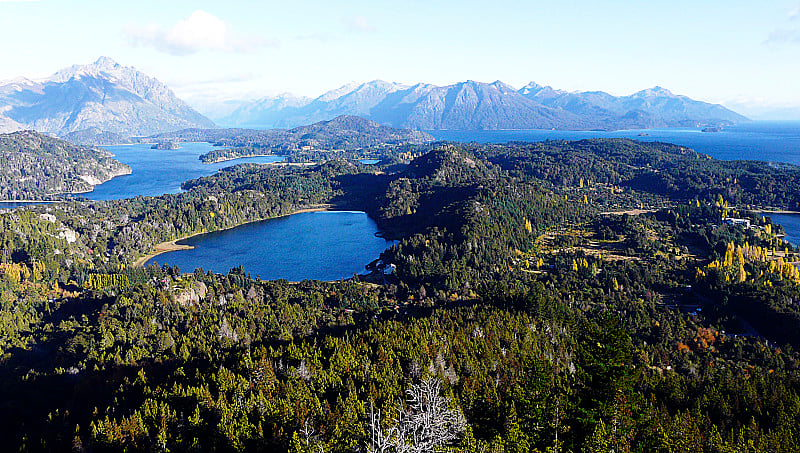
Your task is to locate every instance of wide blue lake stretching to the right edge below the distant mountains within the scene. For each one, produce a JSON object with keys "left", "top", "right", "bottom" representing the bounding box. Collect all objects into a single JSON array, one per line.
[{"left": 428, "top": 121, "right": 800, "bottom": 165}]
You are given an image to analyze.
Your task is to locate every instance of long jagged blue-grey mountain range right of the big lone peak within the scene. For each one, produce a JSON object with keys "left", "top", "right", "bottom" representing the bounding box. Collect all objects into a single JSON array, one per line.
[{"left": 214, "top": 80, "right": 747, "bottom": 130}]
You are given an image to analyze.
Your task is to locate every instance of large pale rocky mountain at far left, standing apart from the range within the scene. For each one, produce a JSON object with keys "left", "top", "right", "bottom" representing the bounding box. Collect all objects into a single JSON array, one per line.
[{"left": 0, "top": 57, "right": 215, "bottom": 136}]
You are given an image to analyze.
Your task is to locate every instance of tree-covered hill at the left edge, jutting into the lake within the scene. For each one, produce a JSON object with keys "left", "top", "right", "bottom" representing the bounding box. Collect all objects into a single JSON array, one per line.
[{"left": 0, "top": 131, "right": 131, "bottom": 200}]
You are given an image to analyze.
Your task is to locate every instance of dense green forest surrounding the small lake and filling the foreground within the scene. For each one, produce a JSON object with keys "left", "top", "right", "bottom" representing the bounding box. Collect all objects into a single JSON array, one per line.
[{"left": 0, "top": 140, "right": 800, "bottom": 453}]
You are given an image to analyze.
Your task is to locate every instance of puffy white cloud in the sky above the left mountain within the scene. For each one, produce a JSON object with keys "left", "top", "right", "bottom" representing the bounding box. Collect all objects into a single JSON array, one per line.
[{"left": 125, "top": 10, "right": 276, "bottom": 55}]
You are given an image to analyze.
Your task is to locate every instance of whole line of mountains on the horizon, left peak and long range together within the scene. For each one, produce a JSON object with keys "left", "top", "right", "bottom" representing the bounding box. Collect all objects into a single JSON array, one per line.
[{"left": 0, "top": 57, "right": 747, "bottom": 138}]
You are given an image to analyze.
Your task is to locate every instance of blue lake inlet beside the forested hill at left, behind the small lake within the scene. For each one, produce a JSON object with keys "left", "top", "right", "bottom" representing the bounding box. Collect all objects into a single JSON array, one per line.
[{"left": 87, "top": 143, "right": 284, "bottom": 200}]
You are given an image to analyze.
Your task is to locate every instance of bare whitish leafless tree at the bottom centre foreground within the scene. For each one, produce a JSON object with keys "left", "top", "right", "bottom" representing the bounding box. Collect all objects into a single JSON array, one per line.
[{"left": 367, "top": 378, "right": 467, "bottom": 453}]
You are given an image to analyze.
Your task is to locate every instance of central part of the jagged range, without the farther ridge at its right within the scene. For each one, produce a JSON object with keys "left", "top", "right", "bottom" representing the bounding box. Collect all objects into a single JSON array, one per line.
[{"left": 223, "top": 80, "right": 586, "bottom": 129}]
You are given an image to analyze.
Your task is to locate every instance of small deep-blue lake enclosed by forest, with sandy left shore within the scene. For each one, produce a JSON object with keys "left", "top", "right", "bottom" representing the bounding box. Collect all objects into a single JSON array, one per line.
[{"left": 146, "top": 211, "right": 394, "bottom": 281}]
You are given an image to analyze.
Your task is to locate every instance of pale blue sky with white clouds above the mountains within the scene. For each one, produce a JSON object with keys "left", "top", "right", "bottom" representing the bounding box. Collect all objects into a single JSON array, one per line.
[{"left": 0, "top": 0, "right": 800, "bottom": 119}]
